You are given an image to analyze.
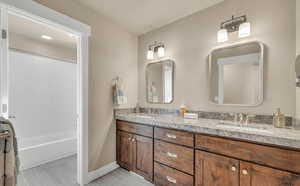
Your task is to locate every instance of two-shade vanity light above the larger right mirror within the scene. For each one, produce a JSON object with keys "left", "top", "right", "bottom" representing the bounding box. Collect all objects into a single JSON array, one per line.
[{"left": 218, "top": 15, "right": 251, "bottom": 43}]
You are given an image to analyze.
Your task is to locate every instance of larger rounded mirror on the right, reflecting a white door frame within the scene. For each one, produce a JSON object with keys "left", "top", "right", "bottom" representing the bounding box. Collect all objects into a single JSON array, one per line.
[{"left": 209, "top": 42, "right": 264, "bottom": 106}]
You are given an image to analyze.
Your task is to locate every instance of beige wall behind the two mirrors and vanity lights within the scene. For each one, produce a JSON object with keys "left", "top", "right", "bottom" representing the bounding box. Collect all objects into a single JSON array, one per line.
[{"left": 138, "top": 0, "right": 296, "bottom": 115}]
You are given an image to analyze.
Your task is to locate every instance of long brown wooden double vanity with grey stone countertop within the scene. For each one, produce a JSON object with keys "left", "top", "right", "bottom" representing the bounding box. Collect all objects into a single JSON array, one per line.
[{"left": 116, "top": 113, "right": 300, "bottom": 186}]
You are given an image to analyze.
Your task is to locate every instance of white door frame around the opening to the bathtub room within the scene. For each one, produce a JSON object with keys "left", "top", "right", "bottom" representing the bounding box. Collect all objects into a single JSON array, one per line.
[{"left": 0, "top": 0, "right": 91, "bottom": 185}]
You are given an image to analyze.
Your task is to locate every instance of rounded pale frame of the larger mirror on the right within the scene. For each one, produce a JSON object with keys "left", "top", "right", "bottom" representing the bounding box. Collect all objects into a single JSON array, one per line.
[{"left": 208, "top": 41, "right": 265, "bottom": 107}]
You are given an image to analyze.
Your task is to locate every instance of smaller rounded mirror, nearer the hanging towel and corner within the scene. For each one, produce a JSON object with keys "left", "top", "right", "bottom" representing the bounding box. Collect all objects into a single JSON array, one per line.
[{"left": 146, "top": 60, "right": 174, "bottom": 104}]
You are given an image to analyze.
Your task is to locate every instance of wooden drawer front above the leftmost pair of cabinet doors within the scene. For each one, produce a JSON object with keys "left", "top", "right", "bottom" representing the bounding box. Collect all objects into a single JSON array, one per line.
[{"left": 117, "top": 120, "right": 153, "bottom": 138}]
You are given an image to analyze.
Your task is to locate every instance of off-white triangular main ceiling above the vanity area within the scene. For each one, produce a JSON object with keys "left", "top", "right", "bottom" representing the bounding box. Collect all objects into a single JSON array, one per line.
[{"left": 77, "top": 0, "right": 223, "bottom": 35}]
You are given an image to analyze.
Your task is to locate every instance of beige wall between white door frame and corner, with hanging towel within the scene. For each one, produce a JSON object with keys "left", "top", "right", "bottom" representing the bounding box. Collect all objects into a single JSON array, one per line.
[{"left": 36, "top": 0, "right": 137, "bottom": 171}]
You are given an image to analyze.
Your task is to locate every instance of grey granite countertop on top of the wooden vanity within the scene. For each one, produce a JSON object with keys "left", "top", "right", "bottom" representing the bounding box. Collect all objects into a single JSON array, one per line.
[{"left": 115, "top": 113, "right": 300, "bottom": 149}]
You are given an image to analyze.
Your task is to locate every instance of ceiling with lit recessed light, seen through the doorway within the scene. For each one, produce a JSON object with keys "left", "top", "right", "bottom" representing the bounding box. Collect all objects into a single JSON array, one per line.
[{"left": 8, "top": 15, "right": 76, "bottom": 49}]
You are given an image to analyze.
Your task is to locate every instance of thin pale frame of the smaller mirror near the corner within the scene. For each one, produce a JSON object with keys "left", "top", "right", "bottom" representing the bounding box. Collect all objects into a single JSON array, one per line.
[{"left": 145, "top": 59, "right": 175, "bottom": 105}]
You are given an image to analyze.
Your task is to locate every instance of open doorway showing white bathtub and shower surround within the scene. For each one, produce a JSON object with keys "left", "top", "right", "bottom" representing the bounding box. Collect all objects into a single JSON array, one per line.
[{"left": 8, "top": 13, "right": 77, "bottom": 170}]
